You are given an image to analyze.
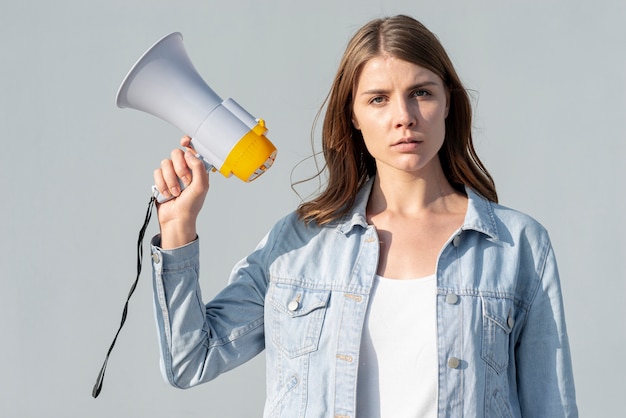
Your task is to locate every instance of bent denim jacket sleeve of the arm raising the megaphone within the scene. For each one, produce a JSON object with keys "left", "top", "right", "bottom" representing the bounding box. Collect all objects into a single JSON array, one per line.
[{"left": 151, "top": 230, "right": 267, "bottom": 388}]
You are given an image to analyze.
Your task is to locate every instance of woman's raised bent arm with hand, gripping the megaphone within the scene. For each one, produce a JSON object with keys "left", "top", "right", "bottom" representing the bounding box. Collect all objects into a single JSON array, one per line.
[{"left": 152, "top": 137, "right": 265, "bottom": 388}]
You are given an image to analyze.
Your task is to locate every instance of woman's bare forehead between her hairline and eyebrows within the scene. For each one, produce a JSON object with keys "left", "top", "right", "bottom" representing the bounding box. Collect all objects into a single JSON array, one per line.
[{"left": 356, "top": 54, "right": 443, "bottom": 90}]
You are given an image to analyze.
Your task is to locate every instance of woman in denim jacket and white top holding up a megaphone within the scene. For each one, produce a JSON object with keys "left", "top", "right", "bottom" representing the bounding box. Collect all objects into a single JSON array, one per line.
[{"left": 152, "top": 16, "right": 577, "bottom": 418}]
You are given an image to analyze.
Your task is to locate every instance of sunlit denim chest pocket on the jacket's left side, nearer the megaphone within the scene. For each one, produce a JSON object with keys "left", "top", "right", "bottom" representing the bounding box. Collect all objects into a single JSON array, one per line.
[{"left": 268, "top": 283, "right": 330, "bottom": 358}]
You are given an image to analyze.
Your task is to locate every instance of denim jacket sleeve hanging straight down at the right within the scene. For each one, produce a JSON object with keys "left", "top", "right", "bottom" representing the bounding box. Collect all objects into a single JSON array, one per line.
[{"left": 516, "top": 241, "right": 578, "bottom": 418}]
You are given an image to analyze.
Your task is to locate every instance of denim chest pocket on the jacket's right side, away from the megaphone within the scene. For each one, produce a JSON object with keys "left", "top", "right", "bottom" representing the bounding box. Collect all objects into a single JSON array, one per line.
[{"left": 481, "top": 297, "right": 515, "bottom": 374}]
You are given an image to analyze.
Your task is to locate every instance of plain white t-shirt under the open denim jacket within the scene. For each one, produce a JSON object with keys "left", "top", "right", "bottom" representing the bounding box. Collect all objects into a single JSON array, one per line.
[{"left": 356, "top": 275, "right": 438, "bottom": 418}]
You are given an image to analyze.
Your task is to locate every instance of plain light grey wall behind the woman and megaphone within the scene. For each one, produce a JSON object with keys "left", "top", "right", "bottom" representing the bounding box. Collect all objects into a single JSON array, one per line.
[{"left": 0, "top": 0, "right": 626, "bottom": 417}]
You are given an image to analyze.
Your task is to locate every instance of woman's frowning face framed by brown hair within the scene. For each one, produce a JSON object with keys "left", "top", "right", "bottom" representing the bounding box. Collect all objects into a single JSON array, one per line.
[{"left": 352, "top": 55, "right": 448, "bottom": 175}]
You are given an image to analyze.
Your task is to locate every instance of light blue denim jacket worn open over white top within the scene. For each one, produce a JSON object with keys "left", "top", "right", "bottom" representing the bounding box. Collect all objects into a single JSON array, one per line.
[{"left": 152, "top": 181, "right": 578, "bottom": 418}]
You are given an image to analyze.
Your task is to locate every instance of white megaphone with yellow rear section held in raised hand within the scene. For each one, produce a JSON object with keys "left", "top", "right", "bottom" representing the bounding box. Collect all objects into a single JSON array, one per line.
[{"left": 117, "top": 32, "right": 276, "bottom": 202}]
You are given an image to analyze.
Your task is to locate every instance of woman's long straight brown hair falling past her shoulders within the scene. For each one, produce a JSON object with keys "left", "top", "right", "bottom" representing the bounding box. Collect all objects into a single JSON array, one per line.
[{"left": 297, "top": 15, "right": 498, "bottom": 225}]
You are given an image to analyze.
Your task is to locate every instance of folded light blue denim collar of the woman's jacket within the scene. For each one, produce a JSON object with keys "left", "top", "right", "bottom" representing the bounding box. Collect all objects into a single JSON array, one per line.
[{"left": 337, "top": 177, "right": 499, "bottom": 240}]
